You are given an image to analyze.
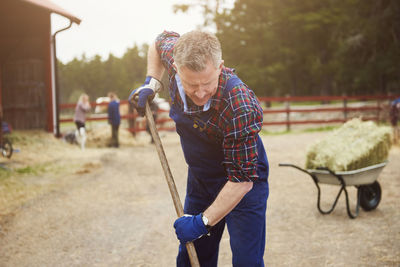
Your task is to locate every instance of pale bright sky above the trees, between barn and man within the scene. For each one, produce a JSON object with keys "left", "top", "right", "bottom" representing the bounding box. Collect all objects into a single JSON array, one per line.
[{"left": 51, "top": 0, "right": 212, "bottom": 63}]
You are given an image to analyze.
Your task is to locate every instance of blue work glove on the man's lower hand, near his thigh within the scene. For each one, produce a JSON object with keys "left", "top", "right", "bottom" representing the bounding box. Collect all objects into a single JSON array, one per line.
[{"left": 174, "top": 214, "right": 208, "bottom": 244}]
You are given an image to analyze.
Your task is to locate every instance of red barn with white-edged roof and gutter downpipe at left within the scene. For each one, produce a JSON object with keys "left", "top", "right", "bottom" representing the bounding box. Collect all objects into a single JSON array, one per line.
[{"left": 0, "top": 0, "right": 80, "bottom": 133}]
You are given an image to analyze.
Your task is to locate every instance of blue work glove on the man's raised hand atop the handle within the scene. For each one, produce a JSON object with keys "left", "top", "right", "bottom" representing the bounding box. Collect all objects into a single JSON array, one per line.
[{"left": 128, "top": 76, "right": 162, "bottom": 117}]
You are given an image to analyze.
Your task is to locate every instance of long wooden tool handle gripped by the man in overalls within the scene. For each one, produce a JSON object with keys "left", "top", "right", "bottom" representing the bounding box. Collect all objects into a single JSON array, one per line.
[{"left": 146, "top": 102, "right": 200, "bottom": 267}]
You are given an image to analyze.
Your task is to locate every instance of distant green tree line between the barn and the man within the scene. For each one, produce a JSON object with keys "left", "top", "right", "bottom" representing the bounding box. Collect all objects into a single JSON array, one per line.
[{"left": 58, "top": 45, "right": 148, "bottom": 103}]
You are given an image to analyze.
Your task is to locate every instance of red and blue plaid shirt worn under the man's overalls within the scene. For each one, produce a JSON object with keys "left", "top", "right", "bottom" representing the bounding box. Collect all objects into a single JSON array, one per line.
[{"left": 156, "top": 31, "right": 263, "bottom": 182}]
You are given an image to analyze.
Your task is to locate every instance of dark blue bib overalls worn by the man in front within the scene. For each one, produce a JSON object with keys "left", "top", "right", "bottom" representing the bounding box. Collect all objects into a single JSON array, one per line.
[{"left": 170, "top": 76, "right": 269, "bottom": 267}]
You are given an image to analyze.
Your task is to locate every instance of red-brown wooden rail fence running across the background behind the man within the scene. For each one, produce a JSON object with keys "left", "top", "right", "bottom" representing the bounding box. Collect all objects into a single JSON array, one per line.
[{"left": 60, "top": 95, "right": 400, "bottom": 133}]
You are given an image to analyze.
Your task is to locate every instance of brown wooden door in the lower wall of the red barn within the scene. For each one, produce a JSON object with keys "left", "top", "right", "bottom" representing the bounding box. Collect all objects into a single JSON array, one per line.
[{"left": 1, "top": 59, "right": 47, "bottom": 129}]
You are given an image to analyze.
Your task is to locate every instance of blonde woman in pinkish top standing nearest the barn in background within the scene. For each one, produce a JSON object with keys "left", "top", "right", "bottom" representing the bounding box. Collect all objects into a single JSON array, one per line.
[{"left": 74, "top": 94, "right": 91, "bottom": 150}]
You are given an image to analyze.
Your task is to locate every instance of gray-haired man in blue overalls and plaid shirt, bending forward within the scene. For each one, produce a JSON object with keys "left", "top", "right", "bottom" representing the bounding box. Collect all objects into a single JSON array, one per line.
[{"left": 130, "top": 31, "right": 269, "bottom": 267}]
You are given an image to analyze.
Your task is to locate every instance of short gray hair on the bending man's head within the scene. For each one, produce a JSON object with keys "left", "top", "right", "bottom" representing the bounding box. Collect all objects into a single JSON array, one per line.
[{"left": 173, "top": 30, "right": 222, "bottom": 71}]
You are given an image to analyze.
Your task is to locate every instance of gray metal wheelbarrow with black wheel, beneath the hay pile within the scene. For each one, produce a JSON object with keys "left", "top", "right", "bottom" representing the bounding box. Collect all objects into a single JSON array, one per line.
[{"left": 279, "top": 161, "right": 388, "bottom": 219}]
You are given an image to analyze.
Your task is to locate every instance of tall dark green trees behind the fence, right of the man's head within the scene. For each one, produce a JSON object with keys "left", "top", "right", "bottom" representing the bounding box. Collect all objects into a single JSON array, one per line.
[{"left": 178, "top": 0, "right": 400, "bottom": 95}]
